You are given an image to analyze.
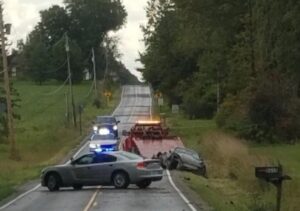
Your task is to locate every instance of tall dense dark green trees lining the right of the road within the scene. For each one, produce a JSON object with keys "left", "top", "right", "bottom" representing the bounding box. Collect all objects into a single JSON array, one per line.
[{"left": 140, "top": 0, "right": 300, "bottom": 142}]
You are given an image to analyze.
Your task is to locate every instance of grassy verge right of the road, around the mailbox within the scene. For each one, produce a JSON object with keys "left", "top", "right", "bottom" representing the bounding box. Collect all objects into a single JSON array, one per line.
[{"left": 168, "top": 113, "right": 300, "bottom": 211}]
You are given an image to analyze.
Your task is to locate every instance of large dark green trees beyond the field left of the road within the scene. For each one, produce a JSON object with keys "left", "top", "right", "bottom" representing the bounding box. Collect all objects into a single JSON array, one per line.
[{"left": 16, "top": 0, "right": 138, "bottom": 84}]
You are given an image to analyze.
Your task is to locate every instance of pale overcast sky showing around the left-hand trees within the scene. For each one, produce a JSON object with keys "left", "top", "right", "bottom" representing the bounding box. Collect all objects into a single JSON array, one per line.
[{"left": 3, "top": 0, "right": 147, "bottom": 79}]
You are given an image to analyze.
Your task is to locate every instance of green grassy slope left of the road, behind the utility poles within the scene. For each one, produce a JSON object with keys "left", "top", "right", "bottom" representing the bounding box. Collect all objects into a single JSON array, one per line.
[{"left": 0, "top": 82, "right": 119, "bottom": 200}]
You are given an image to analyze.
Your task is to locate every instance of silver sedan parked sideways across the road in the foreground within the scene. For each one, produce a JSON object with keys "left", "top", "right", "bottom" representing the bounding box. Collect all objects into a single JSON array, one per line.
[{"left": 41, "top": 151, "right": 163, "bottom": 191}]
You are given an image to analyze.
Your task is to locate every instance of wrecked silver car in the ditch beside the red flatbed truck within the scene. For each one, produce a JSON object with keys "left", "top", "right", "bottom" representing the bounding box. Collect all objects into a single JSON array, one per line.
[{"left": 158, "top": 147, "right": 206, "bottom": 176}]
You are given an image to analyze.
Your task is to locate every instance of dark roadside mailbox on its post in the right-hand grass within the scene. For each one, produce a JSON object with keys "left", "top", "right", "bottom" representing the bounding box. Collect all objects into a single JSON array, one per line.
[{"left": 255, "top": 165, "right": 292, "bottom": 211}]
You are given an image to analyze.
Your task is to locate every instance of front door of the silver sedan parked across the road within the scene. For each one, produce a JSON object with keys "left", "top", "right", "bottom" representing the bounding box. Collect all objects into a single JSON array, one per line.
[{"left": 71, "top": 154, "right": 94, "bottom": 185}]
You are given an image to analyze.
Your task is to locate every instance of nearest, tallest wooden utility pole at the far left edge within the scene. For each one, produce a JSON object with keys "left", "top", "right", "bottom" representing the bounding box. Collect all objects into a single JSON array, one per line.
[{"left": 0, "top": 1, "right": 20, "bottom": 160}]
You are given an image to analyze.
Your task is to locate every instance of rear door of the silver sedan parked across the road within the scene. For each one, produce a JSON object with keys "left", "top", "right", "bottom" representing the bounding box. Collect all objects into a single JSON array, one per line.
[{"left": 88, "top": 154, "right": 117, "bottom": 184}]
